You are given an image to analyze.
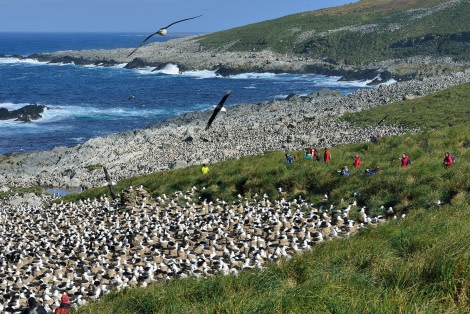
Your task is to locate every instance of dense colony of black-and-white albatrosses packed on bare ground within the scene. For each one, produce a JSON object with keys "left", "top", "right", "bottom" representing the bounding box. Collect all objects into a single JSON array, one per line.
[{"left": 0, "top": 187, "right": 393, "bottom": 312}]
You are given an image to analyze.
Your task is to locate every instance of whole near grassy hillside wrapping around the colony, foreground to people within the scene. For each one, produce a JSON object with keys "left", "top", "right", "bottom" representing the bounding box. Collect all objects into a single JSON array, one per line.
[{"left": 69, "top": 84, "right": 470, "bottom": 313}]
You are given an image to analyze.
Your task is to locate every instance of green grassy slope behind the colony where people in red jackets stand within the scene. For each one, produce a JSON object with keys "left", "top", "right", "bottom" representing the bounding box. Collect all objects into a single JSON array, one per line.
[{"left": 65, "top": 84, "right": 470, "bottom": 213}]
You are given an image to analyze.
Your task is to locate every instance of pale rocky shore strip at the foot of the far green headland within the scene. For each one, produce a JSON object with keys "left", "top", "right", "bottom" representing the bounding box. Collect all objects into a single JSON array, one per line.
[{"left": 23, "top": 35, "right": 470, "bottom": 81}]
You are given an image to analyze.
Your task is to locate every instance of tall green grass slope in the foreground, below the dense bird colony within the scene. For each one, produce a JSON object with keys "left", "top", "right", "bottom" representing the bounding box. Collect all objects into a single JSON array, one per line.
[{"left": 73, "top": 205, "right": 470, "bottom": 313}]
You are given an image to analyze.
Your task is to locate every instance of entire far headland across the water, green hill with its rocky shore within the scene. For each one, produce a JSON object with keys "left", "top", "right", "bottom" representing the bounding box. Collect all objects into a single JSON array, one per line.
[{"left": 30, "top": 0, "right": 470, "bottom": 80}]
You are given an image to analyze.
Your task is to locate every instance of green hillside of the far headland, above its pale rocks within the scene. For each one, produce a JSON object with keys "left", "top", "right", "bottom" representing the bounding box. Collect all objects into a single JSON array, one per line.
[{"left": 196, "top": 0, "right": 470, "bottom": 65}]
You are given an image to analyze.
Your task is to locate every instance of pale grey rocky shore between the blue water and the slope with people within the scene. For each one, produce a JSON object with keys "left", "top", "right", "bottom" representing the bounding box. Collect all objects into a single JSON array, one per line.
[{"left": 0, "top": 70, "right": 470, "bottom": 189}]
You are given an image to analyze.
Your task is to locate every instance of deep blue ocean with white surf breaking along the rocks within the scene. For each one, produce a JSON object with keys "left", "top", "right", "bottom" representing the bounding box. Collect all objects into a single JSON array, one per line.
[{"left": 0, "top": 33, "right": 373, "bottom": 154}]
